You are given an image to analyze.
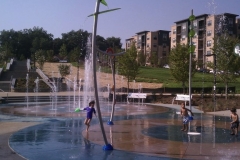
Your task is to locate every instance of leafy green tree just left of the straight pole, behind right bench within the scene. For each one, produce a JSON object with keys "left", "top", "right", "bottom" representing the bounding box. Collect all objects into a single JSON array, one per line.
[{"left": 169, "top": 44, "right": 196, "bottom": 93}]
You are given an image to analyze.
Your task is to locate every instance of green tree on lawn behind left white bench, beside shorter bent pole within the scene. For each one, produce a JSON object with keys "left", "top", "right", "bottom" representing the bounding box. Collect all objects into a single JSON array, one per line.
[{"left": 117, "top": 44, "right": 139, "bottom": 92}]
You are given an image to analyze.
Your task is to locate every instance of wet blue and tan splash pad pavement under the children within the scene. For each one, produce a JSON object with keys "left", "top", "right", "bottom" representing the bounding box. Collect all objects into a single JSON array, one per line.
[{"left": 0, "top": 104, "right": 240, "bottom": 160}]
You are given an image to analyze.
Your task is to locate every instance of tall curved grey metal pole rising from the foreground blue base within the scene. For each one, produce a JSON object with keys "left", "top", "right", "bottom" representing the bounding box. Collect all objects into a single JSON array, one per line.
[{"left": 92, "top": 0, "right": 109, "bottom": 146}]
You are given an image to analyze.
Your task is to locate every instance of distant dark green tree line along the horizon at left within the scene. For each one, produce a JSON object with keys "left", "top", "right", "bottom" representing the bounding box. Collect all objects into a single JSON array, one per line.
[{"left": 0, "top": 27, "right": 122, "bottom": 62}]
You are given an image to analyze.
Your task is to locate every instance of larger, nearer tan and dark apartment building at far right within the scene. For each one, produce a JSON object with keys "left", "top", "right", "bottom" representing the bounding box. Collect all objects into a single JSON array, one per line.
[{"left": 170, "top": 13, "right": 240, "bottom": 68}]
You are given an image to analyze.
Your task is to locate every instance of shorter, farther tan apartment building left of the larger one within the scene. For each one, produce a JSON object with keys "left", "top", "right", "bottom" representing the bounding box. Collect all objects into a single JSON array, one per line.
[{"left": 125, "top": 30, "right": 170, "bottom": 65}]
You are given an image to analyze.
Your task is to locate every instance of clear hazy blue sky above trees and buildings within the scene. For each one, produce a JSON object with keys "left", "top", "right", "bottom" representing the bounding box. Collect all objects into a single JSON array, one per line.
[{"left": 0, "top": 0, "right": 240, "bottom": 47}]
